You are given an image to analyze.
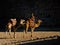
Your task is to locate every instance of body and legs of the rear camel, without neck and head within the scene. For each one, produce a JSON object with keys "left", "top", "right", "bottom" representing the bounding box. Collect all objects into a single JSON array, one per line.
[{"left": 6, "top": 19, "right": 17, "bottom": 38}]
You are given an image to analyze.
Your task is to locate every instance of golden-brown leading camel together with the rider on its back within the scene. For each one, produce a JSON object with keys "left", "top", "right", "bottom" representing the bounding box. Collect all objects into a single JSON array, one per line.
[{"left": 25, "top": 13, "right": 42, "bottom": 38}]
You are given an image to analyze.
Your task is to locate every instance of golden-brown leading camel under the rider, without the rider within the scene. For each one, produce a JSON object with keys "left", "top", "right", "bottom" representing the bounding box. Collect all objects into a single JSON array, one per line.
[{"left": 25, "top": 20, "right": 42, "bottom": 38}]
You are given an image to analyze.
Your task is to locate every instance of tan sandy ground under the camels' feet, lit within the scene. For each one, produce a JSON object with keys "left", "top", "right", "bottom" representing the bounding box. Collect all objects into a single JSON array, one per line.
[{"left": 0, "top": 31, "right": 60, "bottom": 45}]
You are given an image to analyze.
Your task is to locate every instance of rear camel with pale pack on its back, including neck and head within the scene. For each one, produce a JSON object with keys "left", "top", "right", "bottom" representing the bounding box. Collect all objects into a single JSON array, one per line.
[{"left": 6, "top": 19, "right": 25, "bottom": 38}]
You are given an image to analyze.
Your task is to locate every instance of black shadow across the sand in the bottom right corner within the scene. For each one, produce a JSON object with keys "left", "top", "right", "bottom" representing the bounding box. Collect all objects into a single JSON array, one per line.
[{"left": 19, "top": 36, "right": 60, "bottom": 45}]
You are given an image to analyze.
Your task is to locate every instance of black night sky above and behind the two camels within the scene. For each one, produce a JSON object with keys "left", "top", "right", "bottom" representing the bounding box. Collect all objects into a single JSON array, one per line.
[{"left": 0, "top": 0, "right": 60, "bottom": 30}]
